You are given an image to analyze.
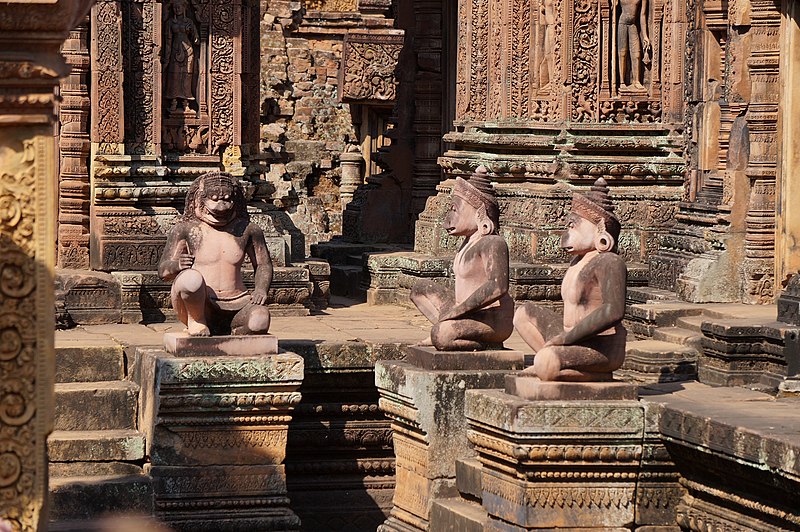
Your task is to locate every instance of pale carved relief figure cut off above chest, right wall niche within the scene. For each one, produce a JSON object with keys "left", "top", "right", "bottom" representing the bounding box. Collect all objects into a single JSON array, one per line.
[{"left": 612, "top": 0, "right": 653, "bottom": 92}]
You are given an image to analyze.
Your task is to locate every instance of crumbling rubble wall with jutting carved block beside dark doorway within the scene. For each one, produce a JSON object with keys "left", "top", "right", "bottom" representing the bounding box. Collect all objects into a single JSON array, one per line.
[{"left": 261, "top": 0, "right": 402, "bottom": 254}]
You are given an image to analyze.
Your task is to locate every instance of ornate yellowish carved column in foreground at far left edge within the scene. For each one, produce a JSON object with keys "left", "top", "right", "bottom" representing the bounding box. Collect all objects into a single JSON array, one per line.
[{"left": 0, "top": 0, "right": 91, "bottom": 530}]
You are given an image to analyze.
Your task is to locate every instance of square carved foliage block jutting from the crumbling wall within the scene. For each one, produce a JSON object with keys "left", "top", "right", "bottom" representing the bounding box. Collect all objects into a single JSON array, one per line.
[{"left": 339, "top": 33, "right": 404, "bottom": 103}]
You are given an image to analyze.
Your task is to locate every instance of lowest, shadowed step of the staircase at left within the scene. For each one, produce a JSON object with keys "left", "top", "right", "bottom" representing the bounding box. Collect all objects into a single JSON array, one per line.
[{"left": 49, "top": 475, "right": 153, "bottom": 520}]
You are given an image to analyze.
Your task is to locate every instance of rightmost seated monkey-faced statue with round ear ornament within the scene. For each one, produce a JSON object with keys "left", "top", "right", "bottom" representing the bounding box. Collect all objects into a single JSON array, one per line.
[{"left": 514, "top": 178, "right": 628, "bottom": 381}]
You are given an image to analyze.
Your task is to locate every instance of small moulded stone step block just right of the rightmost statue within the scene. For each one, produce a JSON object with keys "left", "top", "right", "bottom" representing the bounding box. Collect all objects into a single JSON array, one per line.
[{"left": 616, "top": 340, "right": 698, "bottom": 384}]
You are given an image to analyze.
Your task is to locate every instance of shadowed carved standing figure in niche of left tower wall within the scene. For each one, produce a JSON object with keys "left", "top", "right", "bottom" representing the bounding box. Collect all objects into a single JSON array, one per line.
[{"left": 161, "top": 0, "right": 200, "bottom": 114}]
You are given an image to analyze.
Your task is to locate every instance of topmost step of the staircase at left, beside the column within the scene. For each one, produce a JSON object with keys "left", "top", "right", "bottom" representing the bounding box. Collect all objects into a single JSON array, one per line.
[{"left": 56, "top": 344, "right": 125, "bottom": 382}]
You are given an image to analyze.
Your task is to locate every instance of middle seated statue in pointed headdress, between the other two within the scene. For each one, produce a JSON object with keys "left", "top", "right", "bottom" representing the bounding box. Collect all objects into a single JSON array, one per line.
[{"left": 411, "top": 166, "right": 514, "bottom": 351}]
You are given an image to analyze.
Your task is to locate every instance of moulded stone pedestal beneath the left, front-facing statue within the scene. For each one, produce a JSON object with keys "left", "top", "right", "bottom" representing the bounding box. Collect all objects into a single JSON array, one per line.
[{"left": 138, "top": 339, "right": 304, "bottom": 531}]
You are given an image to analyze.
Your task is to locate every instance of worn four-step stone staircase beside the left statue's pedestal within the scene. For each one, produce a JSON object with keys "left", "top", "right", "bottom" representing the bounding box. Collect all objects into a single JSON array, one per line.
[{"left": 48, "top": 339, "right": 153, "bottom": 532}]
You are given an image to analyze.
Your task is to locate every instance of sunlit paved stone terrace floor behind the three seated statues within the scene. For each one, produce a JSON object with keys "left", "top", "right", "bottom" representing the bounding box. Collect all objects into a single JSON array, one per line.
[{"left": 56, "top": 297, "right": 530, "bottom": 352}]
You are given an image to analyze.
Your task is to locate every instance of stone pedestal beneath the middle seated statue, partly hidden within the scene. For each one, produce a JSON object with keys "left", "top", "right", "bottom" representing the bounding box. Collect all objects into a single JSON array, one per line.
[{"left": 375, "top": 348, "right": 523, "bottom": 532}]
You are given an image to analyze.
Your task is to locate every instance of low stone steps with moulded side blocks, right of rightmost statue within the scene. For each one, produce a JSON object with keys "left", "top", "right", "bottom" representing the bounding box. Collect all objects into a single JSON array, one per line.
[{"left": 618, "top": 287, "right": 791, "bottom": 393}]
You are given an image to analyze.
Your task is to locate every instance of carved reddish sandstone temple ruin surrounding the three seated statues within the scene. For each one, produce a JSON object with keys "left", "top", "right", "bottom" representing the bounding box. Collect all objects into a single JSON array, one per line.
[{"left": 0, "top": 0, "right": 800, "bottom": 532}]
